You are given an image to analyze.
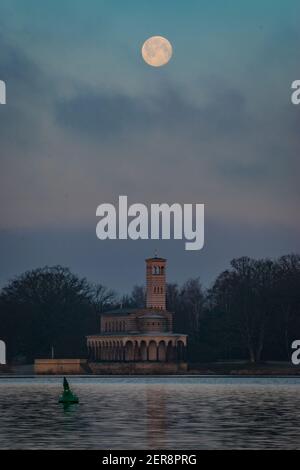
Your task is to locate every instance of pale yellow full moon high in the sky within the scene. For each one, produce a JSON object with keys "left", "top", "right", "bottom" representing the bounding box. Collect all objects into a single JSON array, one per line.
[{"left": 142, "top": 36, "right": 173, "bottom": 67}]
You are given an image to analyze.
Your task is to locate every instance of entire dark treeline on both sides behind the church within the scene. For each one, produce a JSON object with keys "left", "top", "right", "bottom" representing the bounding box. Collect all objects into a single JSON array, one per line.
[{"left": 0, "top": 255, "right": 300, "bottom": 363}]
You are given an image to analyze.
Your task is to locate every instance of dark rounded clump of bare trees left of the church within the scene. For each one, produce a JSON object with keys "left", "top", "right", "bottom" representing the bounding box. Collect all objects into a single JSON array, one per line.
[{"left": 0, "top": 266, "right": 116, "bottom": 362}]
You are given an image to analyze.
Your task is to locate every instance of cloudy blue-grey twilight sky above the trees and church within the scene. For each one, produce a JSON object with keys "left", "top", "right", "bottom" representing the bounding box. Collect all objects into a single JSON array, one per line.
[{"left": 0, "top": 0, "right": 300, "bottom": 292}]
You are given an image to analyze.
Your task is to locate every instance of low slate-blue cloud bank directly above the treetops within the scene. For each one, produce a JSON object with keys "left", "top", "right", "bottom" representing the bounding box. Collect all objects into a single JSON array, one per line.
[{"left": 0, "top": 217, "right": 299, "bottom": 293}]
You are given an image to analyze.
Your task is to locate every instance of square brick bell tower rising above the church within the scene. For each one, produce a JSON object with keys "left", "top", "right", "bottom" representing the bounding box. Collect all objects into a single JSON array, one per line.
[{"left": 146, "top": 257, "right": 167, "bottom": 310}]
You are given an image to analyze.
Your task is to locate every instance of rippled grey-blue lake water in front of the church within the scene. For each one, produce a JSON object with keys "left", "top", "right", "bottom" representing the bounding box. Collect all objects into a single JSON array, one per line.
[{"left": 0, "top": 377, "right": 300, "bottom": 450}]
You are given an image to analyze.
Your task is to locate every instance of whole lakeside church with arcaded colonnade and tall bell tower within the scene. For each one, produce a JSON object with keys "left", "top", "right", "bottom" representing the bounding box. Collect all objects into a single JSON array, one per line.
[{"left": 87, "top": 256, "right": 187, "bottom": 374}]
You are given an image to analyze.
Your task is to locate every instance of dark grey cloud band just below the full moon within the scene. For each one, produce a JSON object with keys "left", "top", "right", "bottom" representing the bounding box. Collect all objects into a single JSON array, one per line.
[{"left": 56, "top": 85, "right": 249, "bottom": 139}]
